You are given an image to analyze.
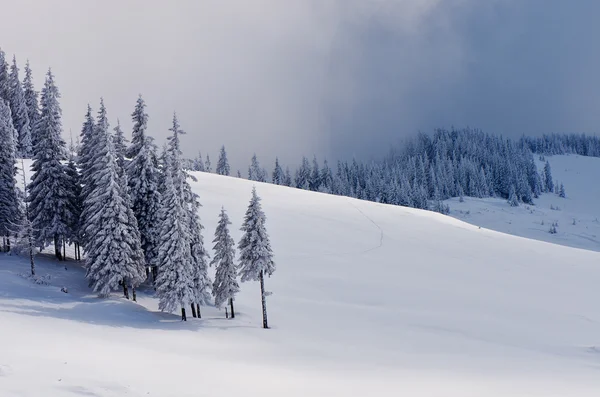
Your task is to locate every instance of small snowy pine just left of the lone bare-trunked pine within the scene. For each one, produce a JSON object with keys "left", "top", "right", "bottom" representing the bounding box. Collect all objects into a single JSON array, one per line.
[{"left": 210, "top": 208, "right": 240, "bottom": 318}]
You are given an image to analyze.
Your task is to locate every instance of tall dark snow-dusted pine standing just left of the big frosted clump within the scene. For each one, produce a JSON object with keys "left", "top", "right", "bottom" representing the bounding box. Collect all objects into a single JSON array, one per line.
[{"left": 28, "top": 70, "right": 69, "bottom": 260}]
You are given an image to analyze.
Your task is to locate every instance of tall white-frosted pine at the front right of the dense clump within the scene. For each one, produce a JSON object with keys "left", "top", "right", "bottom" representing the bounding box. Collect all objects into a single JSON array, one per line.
[{"left": 155, "top": 148, "right": 195, "bottom": 321}]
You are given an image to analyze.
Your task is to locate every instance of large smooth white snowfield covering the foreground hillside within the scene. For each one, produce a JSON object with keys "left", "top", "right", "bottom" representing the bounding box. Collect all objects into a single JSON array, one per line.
[{"left": 0, "top": 159, "right": 600, "bottom": 397}]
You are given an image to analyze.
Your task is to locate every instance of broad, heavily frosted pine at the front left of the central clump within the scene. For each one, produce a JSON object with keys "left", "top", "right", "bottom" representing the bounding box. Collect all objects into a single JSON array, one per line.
[{"left": 83, "top": 102, "right": 146, "bottom": 299}]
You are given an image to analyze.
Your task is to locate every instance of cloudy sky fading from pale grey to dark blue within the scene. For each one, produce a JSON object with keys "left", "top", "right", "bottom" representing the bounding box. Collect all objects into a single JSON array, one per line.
[{"left": 0, "top": 0, "right": 600, "bottom": 171}]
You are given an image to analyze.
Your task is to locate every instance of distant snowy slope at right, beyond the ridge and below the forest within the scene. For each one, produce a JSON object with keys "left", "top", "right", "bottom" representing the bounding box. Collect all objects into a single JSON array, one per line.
[{"left": 446, "top": 155, "right": 600, "bottom": 251}]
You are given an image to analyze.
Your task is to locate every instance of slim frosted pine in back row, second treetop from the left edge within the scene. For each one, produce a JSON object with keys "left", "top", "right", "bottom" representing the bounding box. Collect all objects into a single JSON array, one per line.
[{"left": 8, "top": 57, "right": 32, "bottom": 159}]
